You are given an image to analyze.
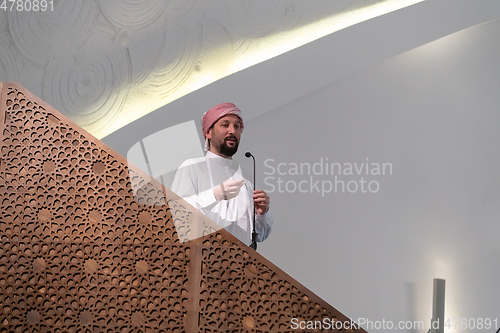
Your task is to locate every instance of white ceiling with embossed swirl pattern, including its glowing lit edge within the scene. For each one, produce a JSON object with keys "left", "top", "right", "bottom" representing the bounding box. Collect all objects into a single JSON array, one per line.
[{"left": 0, "top": 0, "right": 422, "bottom": 138}]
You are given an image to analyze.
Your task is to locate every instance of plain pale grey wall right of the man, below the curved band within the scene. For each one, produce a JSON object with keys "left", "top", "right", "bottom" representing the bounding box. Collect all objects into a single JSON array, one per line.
[{"left": 242, "top": 20, "right": 500, "bottom": 332}]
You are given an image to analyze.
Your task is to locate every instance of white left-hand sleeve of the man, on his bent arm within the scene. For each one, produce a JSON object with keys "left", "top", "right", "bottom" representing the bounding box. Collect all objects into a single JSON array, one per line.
[{"left": 171, "top": 162, "right": 218, "bottom": 210}]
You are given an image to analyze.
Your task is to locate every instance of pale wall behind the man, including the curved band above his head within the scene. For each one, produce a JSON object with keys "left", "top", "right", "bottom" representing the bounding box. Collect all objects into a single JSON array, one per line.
[{"left": 103, "top": 1, "right": 500, "bottom": 332}]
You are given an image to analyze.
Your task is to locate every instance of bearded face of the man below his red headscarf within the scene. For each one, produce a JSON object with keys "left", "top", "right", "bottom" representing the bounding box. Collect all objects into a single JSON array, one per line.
[{"left": 207, "top": 114, "right": 242, "bottom": 158}]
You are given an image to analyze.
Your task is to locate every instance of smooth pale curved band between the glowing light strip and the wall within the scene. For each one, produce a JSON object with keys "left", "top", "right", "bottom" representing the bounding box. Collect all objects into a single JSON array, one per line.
[{"left": 103, "top": 0, "right": 500, "bottom": 156}]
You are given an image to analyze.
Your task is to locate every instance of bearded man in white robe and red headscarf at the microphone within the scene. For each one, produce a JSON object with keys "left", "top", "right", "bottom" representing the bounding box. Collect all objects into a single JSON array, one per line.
[{"left": 171, "top": 103, "right": 273, "bottom": 245}]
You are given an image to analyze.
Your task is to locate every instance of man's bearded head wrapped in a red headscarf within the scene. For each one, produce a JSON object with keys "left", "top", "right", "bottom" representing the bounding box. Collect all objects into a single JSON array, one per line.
[{"left": 201, "top": 103, "right": 243, "bottom": 158}]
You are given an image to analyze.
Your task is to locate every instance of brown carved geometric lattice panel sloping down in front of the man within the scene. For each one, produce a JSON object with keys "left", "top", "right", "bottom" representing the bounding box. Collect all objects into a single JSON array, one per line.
[{"left": 0, "top": 84, "right": 363, "bottom": 333}]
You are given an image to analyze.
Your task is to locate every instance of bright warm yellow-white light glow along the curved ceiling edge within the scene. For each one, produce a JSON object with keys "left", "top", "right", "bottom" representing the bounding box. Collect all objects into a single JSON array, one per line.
[{"left": 99, "top": 0, "right": 424, "bottom": 138}]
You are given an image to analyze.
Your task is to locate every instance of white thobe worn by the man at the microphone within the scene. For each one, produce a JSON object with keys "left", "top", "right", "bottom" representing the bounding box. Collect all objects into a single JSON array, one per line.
[{"left": 171, "top": 152, "right": 273, "bottom": 245}]
